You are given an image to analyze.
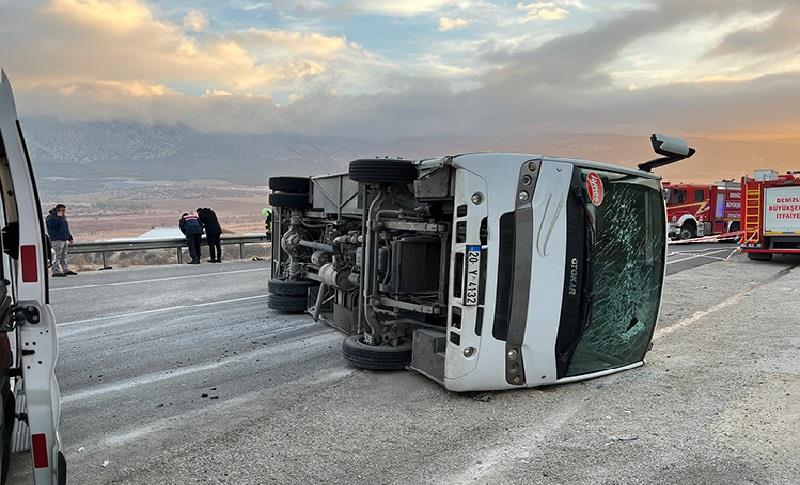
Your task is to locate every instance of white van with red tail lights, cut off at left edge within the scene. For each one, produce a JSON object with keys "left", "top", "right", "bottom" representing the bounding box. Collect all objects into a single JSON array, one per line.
[{"left": 0, "top": 71, "right": 67, "bottom": 485}]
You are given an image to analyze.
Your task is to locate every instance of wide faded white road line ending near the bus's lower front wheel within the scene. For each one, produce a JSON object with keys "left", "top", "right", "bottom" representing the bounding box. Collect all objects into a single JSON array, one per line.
[{"left": 61, "top": 328, "right": 342, "bottom": 404}]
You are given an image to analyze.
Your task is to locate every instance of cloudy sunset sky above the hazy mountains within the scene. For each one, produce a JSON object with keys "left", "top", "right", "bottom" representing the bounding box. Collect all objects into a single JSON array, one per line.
[{"left": 0, "top": 0, "right": 800, "bottom": 139}]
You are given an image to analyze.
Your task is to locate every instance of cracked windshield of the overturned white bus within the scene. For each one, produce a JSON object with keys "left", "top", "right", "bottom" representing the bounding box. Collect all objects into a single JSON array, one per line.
[{"left": 567, "top": 169, "right": 665, "bottom": 376}]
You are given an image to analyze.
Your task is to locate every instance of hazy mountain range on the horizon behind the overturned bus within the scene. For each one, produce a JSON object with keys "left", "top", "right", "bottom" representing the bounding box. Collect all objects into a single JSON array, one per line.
[{"left": 22, "top": 118, "right": 800, "bottom": 185}]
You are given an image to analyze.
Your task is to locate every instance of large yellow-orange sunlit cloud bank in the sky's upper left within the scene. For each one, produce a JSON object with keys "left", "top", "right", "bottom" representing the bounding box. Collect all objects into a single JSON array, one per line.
[{"left": 0, "top": 0, "right": 384, "bottom": 95}]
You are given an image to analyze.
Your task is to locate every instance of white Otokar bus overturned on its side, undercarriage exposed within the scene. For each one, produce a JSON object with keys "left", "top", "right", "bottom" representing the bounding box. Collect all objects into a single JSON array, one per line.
[{"left": 268, "top": 135, "right": 694, "bottom": 391}]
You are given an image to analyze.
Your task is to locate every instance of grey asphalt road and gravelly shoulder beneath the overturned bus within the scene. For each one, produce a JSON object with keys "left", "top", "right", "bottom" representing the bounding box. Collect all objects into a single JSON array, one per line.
[{"left": 11, "top": 245, "right": 800, "bottom": 484}]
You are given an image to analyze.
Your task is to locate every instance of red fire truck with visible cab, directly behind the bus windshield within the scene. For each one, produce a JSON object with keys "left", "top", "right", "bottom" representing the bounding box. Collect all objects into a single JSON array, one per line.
[{"left": 662, "top": 180, "right": 742, "bottom": 239}]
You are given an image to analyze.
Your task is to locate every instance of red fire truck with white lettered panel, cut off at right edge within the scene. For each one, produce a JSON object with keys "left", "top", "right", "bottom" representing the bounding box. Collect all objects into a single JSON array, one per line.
[{"left": 741, "top": 172, "right": 800, "bottom": 261}]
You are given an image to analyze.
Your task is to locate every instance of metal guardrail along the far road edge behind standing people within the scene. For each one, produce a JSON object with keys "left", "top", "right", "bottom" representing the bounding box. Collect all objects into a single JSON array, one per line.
[{"left": 69, "top": 234, "right": 269, "bottom": 268}]
